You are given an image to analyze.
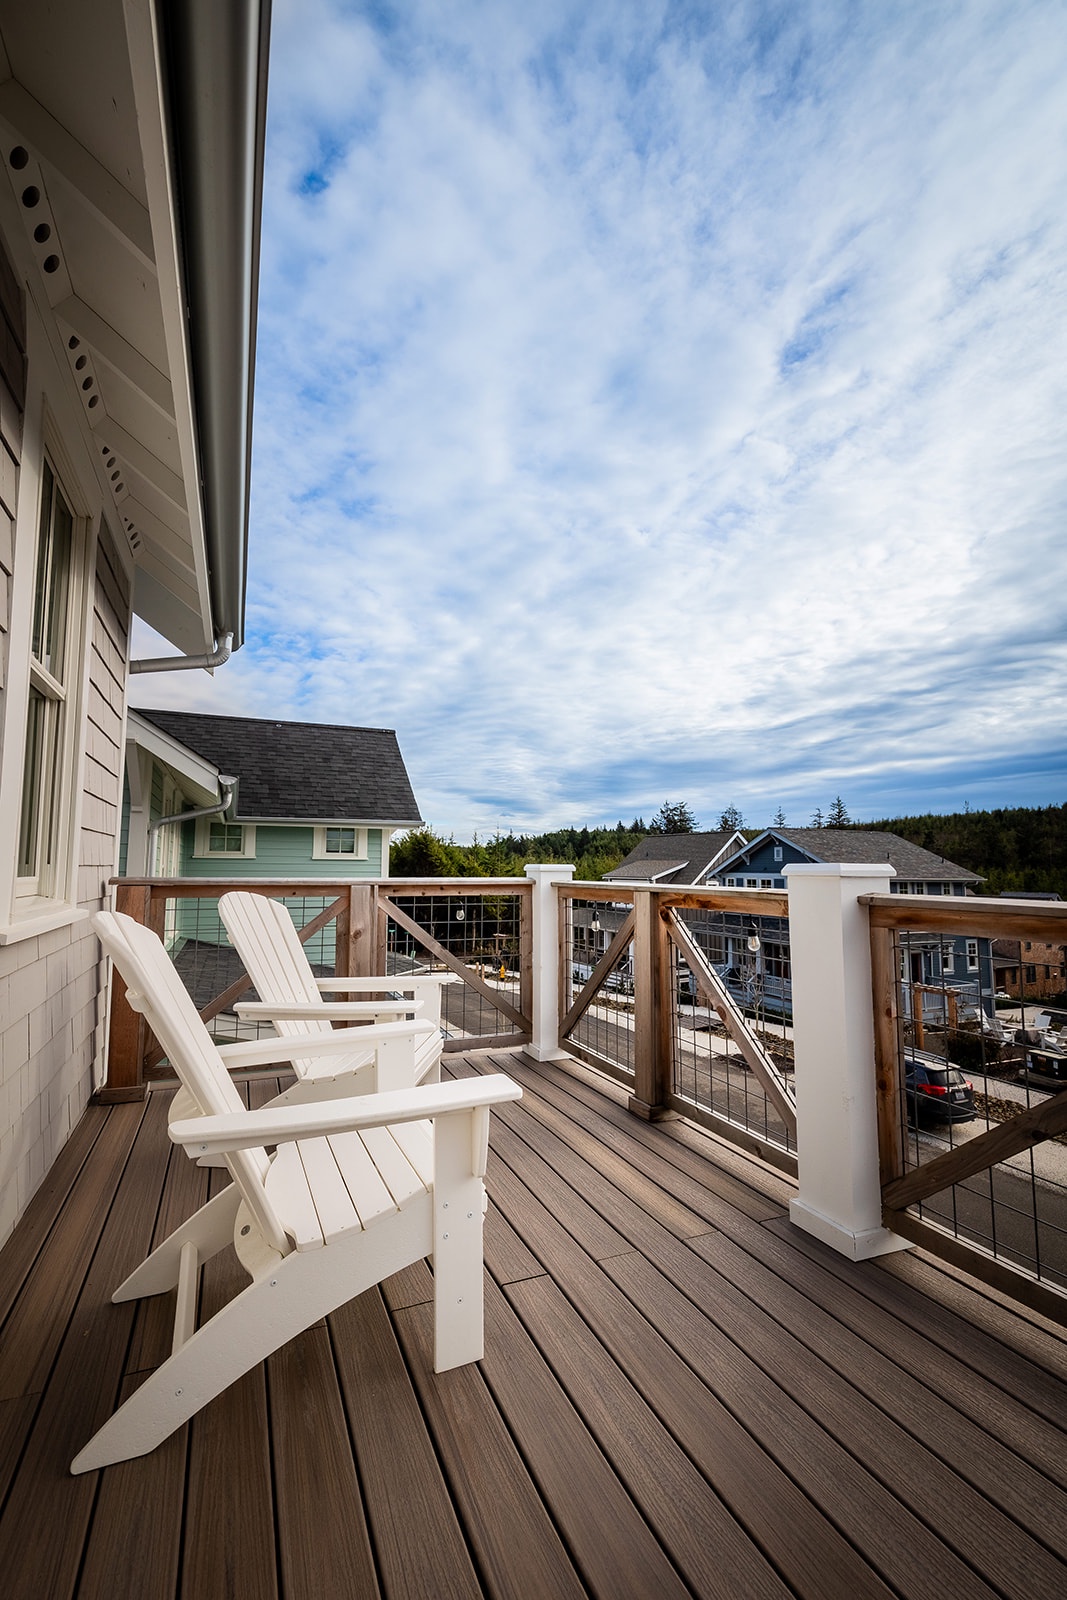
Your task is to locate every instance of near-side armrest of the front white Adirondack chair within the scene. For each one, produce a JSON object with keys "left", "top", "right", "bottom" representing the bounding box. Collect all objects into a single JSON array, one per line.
[{"left": 168, "top": 1072, "right": 522, "bottom": 1155}]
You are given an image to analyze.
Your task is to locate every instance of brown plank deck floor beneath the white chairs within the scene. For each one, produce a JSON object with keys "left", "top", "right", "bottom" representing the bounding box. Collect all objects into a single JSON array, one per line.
[{"left": 0, "top": 1054, "right": 1067, "bottom": 1600}]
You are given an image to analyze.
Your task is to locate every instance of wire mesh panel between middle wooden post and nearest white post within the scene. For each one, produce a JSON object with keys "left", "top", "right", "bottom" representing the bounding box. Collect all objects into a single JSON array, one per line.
[{"left": 670, "top": 909, "right": 797, "bottom": 1155}]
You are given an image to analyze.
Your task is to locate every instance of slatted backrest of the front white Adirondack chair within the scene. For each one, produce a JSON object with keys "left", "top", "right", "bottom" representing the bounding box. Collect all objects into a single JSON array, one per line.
[{"left": 93, "top": 910, "right": 293, "bottom": 1253}]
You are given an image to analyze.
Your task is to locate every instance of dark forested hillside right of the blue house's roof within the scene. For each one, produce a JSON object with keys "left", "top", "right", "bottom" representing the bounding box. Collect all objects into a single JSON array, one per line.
[{"left": 864, "top": 805, "right": 1067, "bottom": 899}]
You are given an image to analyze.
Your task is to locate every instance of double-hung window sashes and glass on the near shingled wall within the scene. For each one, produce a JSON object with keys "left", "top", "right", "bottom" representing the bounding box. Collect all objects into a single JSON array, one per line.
[{"left": 18, "top": 461, "right": 75, "bottom": 894}]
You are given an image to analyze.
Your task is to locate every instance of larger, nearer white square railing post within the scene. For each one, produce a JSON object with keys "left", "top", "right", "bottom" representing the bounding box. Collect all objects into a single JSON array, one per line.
[{"left": 785, "top": 862, "right": 909, "bottom": 1261}]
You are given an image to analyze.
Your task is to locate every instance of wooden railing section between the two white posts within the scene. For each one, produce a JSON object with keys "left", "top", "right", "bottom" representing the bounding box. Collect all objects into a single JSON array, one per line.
[{"left": 557, "top": 883, "right": 797, "bottom": 1170}]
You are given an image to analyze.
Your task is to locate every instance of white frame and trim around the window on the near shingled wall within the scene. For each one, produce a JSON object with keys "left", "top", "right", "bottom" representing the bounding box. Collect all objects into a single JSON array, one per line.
[{"left": 14, "top": 442, "right": 94, "bottom": 917}]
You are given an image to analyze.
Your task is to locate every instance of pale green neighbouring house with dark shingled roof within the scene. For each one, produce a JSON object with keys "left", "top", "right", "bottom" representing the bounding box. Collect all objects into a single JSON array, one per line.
[{"left": 118, "top": 709, "right": 422, "bottom": 960}]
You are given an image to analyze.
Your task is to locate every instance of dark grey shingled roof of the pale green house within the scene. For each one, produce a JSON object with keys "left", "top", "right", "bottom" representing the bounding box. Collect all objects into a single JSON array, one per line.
[{"left": 138, "top": 709, "right": 422, "bottom": 827}]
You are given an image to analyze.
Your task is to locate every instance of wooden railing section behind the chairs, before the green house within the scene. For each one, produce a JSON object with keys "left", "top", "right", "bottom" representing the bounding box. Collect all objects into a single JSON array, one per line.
[{"left": 98, "top": 878, "right": 533, "bottom": 1101}]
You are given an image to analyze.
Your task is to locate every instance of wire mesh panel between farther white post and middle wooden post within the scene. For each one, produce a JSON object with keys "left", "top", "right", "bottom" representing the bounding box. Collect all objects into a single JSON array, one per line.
[{"left": 563, "top": 899, "right": 633, "bottom": 1074}]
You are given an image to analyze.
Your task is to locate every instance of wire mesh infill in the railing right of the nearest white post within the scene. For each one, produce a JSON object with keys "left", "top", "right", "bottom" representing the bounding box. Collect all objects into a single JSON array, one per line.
[{"left": 896, "top": 931, "right": 1067, "bottom": 1290}]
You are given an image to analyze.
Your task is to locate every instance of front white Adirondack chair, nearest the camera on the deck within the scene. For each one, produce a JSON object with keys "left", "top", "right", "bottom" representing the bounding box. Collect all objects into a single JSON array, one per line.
[{"left": 70, "top": 912, "right": 522, "bottom": 1472}]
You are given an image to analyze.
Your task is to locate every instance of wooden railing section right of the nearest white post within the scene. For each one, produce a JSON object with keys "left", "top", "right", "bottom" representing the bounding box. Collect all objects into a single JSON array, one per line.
[{"left": 862, "top": 894, "right": 1067, "bottom": 1322}]
